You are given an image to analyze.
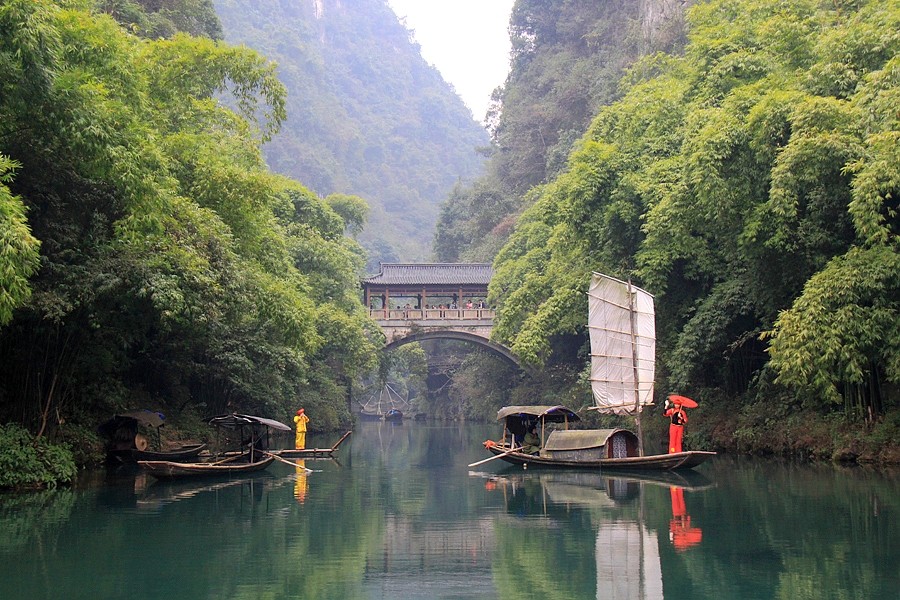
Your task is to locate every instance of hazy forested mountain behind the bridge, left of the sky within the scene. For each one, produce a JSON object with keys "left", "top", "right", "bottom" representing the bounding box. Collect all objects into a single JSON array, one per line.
[{"left": 214, "top": 0, "right": 489, "bottom": 266}]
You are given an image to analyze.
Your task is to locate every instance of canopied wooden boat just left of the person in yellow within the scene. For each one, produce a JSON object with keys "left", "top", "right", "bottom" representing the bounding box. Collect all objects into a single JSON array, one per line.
[{"left": 138, "top": 413, "right": 291, "bottom": 479}]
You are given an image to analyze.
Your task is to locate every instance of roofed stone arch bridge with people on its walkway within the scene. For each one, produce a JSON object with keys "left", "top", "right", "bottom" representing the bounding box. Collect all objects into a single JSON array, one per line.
[{"left": 362, "top": 263, "right": 521, "bottom": 367}]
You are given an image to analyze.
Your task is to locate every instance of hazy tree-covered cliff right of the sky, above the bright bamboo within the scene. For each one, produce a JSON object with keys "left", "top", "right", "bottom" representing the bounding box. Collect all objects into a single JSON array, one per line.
[{"left": 434, "top": 0, "right": 684, "bottom": 261}]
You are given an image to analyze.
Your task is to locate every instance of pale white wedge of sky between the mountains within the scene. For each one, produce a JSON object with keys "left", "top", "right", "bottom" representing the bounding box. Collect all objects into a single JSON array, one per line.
[{"left": 388, "top": 0, "right": 514, "bottom": 122}]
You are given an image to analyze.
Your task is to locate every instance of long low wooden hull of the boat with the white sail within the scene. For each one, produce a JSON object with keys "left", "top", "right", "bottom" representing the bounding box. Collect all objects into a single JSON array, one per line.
[{"left": 488, "top": 444, "right": 716, "bottom": 471}]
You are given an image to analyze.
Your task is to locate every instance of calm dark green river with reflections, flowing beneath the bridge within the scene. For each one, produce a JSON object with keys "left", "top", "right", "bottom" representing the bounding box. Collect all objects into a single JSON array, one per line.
[{"left": 0, "top": 422, "right": 900, "bottom": 600}]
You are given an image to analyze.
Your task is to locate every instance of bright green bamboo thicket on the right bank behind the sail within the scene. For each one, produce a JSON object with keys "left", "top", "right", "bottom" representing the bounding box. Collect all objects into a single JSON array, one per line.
[{"left": 436, "top": 0, "right": 900, "bottom": 460}]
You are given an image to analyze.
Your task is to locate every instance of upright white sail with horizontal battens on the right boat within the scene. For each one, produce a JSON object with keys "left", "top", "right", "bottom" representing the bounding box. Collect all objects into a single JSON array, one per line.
[{"left": 588, "top": 273, "right": 656, "bottom": 414}]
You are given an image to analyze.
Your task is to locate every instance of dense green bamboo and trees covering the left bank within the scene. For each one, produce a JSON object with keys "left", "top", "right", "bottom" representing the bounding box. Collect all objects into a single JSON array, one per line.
[{"left": 0, "top": 0, "right": 378, "bottom": 440}]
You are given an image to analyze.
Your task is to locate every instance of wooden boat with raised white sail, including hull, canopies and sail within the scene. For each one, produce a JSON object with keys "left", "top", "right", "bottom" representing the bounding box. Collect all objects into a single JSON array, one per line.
[{"left": 478, "top": 273, "right": 715, "bottom": 471}]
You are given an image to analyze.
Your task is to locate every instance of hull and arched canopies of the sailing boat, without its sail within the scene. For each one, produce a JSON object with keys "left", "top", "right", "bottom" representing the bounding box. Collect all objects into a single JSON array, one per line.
[{"left": 485, "top": 406, "right": 715, "bottom": 471}]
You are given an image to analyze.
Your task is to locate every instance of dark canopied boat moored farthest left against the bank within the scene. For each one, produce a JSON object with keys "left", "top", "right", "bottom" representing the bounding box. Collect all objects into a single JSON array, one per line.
[{"left": 97, "top": 410, "right": 206, "bottom": 463}]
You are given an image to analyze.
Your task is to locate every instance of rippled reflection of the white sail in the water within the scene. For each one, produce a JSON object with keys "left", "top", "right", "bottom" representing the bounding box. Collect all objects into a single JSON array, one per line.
[{"left": 596, "top": 521, "right": 663, "bottom": 600}]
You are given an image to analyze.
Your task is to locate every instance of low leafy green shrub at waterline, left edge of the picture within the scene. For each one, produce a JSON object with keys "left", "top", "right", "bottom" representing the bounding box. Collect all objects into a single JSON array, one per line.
[{"left": 0, "top": 423, "right": 77, "bottom": 488}]
